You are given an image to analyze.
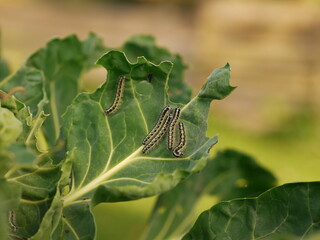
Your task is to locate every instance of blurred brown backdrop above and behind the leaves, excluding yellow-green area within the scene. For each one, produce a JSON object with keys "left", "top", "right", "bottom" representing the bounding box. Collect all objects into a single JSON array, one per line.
[{"left": 0, "top": 0, "right": 320, "bottom": 131}]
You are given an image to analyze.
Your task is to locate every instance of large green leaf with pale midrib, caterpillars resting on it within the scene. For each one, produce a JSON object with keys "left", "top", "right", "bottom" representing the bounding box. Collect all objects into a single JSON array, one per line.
[{"left": 59, "top": 51, "right": 232, "bottom": 206}]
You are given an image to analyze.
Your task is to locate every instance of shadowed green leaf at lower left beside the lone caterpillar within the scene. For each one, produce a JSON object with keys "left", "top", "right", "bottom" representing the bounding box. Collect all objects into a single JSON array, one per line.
[{"left": 5, "top": 163, "right": 60, "bottom": 238}]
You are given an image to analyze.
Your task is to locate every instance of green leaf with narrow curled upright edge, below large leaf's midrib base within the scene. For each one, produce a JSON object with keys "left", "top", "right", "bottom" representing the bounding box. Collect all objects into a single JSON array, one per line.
[{"left": 31, "top": 149, "right": 95, "bottom": 240}]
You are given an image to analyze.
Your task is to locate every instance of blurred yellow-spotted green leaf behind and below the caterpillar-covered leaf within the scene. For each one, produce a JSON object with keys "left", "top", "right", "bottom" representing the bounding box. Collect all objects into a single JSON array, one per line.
[{"left": 145, "top": 150, "right": 276, "bottom": 239}]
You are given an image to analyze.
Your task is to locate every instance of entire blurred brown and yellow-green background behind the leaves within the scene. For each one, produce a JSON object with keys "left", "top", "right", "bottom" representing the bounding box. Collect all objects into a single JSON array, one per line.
[{"left": 0, "top": 0, "right": 320, "bottom": 240}]
